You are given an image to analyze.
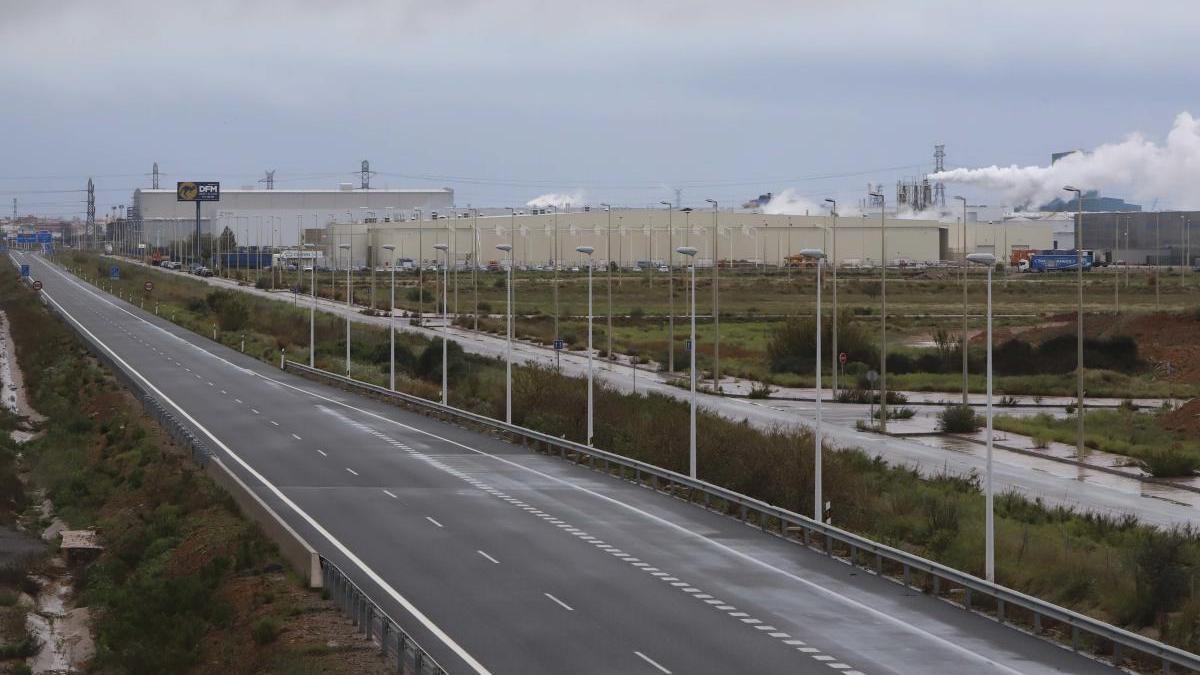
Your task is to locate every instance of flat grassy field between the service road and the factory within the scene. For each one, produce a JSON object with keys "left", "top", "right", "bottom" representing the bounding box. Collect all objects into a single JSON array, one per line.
[{"left": 206, "top": 255, "right": 1200, "bottom": 398}]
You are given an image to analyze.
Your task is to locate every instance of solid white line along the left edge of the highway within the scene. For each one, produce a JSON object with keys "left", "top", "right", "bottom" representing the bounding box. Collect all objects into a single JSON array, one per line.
[{"left": 32, "top": 265, "right": 491, "bottom": 675}]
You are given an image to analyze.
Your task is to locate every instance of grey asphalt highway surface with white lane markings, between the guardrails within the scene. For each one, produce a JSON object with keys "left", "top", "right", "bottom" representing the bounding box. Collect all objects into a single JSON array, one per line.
[{"left": 23, "top": 253, "right": 1111, "bottom": 675}]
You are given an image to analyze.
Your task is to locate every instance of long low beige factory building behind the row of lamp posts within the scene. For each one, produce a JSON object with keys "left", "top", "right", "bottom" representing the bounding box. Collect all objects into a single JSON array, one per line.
[{"left": 326, "top": 209, "right": 948, "bottom": 268}]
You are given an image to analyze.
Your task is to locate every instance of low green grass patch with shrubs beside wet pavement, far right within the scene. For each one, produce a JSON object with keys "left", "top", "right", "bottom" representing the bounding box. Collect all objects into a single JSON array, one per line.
[{"left": 994, "top": 408, "right": 1200, "bottom": 476}]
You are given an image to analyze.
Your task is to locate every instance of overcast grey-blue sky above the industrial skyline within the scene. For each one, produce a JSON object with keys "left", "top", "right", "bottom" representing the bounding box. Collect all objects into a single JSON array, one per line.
[{"left": 0, "top": 0, "right": 1200, "bottom": 215}]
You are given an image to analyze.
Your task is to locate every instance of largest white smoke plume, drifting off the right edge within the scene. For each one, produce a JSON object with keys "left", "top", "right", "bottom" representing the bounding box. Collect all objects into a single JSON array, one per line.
[{"left": 930, "top": 113, "right": 1200, "bottom": 209}]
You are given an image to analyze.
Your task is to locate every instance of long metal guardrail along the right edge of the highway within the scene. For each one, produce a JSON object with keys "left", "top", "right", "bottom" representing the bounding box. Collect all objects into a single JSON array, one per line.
[{"left": 284, "top": 360, "right": 1200, "bottom": 674}]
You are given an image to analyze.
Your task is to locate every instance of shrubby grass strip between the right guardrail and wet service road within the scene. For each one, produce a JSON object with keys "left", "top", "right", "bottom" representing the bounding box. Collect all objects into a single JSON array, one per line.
[{"left": 58, "top": 248, "right": 1200, "bottom": 662}]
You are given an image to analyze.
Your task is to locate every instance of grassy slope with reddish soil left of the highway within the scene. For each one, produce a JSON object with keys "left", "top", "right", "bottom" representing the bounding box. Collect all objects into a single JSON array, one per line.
[{"left": 0, "top": 260, "right": 384, "bottom": 673}]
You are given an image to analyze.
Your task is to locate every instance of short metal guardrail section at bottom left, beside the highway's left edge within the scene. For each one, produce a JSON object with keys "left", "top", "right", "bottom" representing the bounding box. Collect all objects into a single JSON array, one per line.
[{"left": 320, "top": 557, "right": 446, "bottom": 675}]
